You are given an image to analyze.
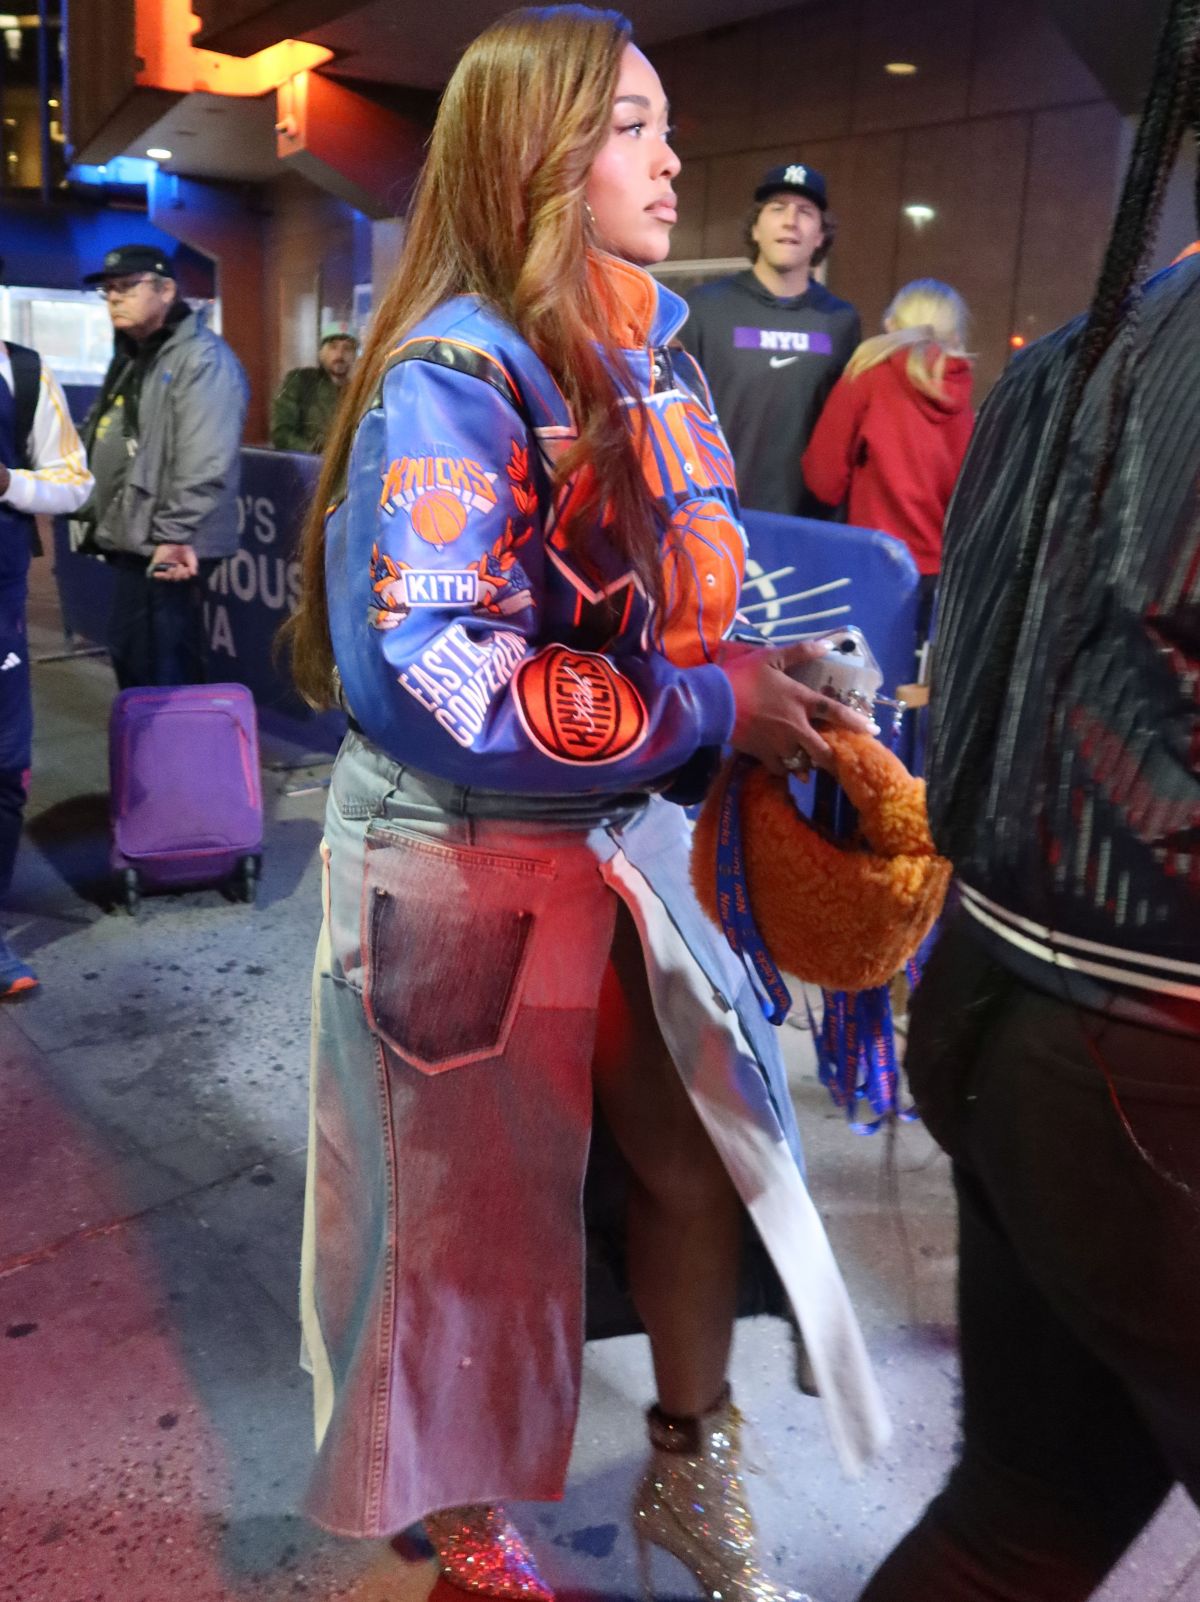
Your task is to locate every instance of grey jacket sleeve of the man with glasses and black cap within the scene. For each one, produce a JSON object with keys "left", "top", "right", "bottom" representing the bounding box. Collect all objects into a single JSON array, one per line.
[{"left": 151, "top": 349, "right": 247, "bottom": 545}]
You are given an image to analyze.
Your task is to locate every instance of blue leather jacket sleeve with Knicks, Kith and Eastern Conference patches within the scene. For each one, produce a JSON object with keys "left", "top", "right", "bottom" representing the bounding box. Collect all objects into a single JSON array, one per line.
[{"left": 327, "top": 360, "right": 734, "bottom": 795}]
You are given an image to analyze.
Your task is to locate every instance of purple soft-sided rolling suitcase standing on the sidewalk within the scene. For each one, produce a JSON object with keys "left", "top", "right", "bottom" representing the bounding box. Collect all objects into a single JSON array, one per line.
[{"left": 109, "top": 684, "right": 263, "bottom": 912}]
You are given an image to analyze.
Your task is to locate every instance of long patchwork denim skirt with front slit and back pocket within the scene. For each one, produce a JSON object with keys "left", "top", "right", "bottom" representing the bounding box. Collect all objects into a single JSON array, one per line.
[{"left": 301, "top": 734, "right": 888, "bottom": 1536}]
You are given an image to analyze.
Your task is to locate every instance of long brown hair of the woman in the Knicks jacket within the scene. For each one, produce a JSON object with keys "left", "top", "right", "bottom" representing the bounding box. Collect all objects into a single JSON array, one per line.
[{"left": 284, "top": 5, "right": 662, "bottom": 706}]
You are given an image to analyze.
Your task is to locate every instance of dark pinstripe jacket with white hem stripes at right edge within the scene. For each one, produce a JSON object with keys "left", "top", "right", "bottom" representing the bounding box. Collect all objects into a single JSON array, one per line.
[{"left": 929, "top": 258, "right": 1200, "bottom": 1027}]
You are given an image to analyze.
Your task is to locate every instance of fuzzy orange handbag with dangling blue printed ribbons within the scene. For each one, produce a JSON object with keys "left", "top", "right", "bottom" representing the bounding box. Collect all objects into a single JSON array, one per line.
[{"left": 692, "top": 628, "right": 952, "bottom": 1134}]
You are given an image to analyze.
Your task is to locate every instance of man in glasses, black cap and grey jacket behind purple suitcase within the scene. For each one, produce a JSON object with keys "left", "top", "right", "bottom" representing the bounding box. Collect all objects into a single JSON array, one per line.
[{"left": 83, "top": 245, "right": 248, "bottom": 689}]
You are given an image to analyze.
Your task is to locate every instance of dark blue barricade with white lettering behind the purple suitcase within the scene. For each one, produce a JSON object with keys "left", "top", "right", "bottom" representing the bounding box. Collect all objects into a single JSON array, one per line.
[{"left": 54, "top": 450, "right": 346, "bottom": 751}]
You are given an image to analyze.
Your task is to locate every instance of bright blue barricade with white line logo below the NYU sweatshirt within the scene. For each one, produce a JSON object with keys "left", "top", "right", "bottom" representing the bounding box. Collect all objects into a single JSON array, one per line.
[{"left": 740, "top": 511, "right": 920, "bottom": 767}]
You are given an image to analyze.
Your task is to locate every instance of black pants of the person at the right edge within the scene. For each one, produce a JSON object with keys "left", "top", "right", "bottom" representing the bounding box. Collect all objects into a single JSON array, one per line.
[{"left": 862, "top": 913, "right": 1200, "bottom": 1602}]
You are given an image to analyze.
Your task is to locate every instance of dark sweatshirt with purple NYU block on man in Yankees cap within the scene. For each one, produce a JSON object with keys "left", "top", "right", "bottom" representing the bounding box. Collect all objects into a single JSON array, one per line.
[{"left": 679, "top": 272, "right": 862, "bottom": 517}]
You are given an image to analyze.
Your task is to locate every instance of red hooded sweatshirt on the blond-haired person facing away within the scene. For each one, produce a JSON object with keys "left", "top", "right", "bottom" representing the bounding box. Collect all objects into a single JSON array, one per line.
[{"left": 804, "top": 349, "right": 974, "bottom": 574}]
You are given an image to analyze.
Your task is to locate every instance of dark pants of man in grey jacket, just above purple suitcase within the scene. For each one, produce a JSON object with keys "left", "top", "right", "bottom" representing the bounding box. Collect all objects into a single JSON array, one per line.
[{"left": 107, "top": 556, "right": 216, "bottom": 690}]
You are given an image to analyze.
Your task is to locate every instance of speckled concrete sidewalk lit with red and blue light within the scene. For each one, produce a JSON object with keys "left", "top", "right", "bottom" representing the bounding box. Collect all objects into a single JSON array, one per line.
[{"left": 0, "top": 621, "right": 1200, "bottom": 1602}]
